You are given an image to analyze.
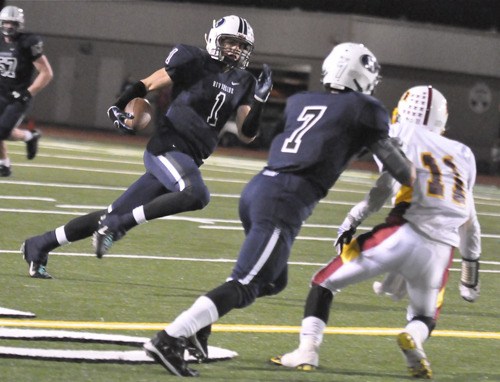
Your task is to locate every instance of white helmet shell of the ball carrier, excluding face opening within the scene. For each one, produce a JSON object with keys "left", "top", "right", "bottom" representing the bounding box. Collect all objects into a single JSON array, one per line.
[{"left": 205, "top": 15, "right": 255, "bottom": 69}]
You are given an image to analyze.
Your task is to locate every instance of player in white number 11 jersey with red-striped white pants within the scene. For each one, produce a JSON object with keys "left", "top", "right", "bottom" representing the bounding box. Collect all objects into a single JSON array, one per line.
[{"left": 271, "top": 86, "right": 481, "bottom": 378}]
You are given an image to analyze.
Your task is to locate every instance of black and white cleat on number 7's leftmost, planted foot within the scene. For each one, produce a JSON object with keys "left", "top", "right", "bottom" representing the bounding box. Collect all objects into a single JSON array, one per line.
[{"left": 143, "top": 330, "right": 198, "bottom": 377}]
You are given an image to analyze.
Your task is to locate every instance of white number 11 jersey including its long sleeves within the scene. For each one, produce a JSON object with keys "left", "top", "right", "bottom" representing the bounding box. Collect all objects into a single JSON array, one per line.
[{"left": 346, "top": 123, "right": 481, "bottom": 260}]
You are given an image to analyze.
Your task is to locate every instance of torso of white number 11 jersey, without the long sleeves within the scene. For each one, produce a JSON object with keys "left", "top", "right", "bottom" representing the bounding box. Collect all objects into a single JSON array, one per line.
[{"left": 392, "top": 124, "right": 477, "bottom": 247}]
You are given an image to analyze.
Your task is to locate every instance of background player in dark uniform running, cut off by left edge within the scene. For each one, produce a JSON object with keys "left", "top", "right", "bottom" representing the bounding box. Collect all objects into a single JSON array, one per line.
[{"left": 0, "top": 5, "right": 53, "bottom": 176}]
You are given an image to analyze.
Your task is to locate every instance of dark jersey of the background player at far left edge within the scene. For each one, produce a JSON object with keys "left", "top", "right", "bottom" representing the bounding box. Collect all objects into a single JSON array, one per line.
[{"left": 0, "top": 33, "right": 43, "bottom": 94}]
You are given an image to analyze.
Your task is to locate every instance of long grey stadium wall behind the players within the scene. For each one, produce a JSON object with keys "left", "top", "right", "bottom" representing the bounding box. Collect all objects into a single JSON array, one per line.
[{"left": 6, "top": 0, "right": 500, "bottom": 167}]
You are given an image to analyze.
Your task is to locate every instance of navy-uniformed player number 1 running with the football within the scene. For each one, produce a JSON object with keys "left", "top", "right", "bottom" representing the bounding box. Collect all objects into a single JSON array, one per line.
[{"left": 21, "top": 15, "right": 272, "bottom": 278}]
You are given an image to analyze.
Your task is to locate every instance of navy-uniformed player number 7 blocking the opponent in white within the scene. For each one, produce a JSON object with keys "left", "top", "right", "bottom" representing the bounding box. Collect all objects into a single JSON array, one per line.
[{"left": 144, "top": 43, "right": 415, "bottom": 376}]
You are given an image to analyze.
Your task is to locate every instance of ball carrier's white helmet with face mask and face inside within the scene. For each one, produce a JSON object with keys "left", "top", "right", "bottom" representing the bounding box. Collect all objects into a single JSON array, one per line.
[{"left": 205, "top": 16, "right": 254, "bottom": 69}]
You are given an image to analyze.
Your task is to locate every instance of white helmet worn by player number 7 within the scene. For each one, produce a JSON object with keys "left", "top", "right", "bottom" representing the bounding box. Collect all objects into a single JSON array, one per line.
[{"left": 322, "top": 42, "right": 380, "bottom": 94}]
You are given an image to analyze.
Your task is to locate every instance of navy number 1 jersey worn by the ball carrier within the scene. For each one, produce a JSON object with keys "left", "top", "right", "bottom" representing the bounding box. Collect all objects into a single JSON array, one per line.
[{"left": 148, "top": 44, "right": 255, "bottom": 163}]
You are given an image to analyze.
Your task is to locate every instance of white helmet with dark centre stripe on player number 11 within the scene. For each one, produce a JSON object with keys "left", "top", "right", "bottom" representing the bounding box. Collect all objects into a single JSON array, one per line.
[{"left": 396, "top": 85, "right": 448, "bottom": 134}]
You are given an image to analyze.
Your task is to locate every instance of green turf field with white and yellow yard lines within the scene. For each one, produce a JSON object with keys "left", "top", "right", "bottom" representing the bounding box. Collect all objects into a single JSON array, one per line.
[{"left": 0, "top": 138, "right": 500, "bottom": 382}]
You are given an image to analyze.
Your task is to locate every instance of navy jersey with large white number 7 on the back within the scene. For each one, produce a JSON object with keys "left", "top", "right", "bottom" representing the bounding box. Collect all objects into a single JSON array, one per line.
[{"left": 266, "top": 91, "right": 389, "bottom": 197}]
